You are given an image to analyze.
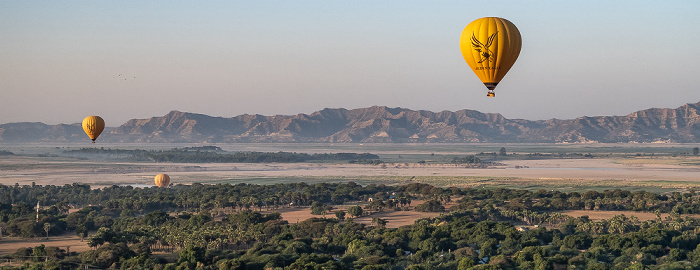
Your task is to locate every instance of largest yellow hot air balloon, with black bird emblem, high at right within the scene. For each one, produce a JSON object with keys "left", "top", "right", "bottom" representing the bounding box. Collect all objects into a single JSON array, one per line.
[{"left": 459, "top": 17, "right": 522, "bottom": 97}]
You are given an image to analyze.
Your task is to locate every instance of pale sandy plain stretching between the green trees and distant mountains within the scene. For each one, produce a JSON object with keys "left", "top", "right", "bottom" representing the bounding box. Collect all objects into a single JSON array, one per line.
[{"left": 0, "top": 156, "right": 700, "bottom": 189}]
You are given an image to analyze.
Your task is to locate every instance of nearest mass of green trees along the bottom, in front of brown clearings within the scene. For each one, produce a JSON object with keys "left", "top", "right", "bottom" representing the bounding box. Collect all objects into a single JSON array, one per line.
[{"left": 13, "top": 208, "right": 700, "bottom": 270}]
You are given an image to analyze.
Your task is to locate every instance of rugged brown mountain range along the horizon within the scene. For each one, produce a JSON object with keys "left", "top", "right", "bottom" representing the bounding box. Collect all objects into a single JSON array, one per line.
[{"left": 0, "top": 103, "right": 700, "bottom": 143}]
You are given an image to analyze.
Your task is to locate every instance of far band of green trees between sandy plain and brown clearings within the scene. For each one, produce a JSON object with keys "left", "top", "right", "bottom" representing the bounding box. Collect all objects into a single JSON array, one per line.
[{"left": 0, "top": 182, "right": 700, "bottom": 221}]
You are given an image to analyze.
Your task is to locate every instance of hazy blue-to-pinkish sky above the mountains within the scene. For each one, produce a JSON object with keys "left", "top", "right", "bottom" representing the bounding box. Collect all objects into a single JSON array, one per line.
[{"left": 0, "top": 0, "right": 700, "bottom": 126}]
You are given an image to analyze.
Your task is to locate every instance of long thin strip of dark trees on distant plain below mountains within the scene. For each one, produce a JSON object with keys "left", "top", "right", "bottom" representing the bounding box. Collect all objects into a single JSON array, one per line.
[{"left": 64, "top": 147, "right": 379, "bottom": 163}]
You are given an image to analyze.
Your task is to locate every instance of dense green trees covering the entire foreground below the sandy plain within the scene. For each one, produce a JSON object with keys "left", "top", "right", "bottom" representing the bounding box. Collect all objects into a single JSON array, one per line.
[{"left": 0, "top": 183, "right": 700, "bottom": 269}]
